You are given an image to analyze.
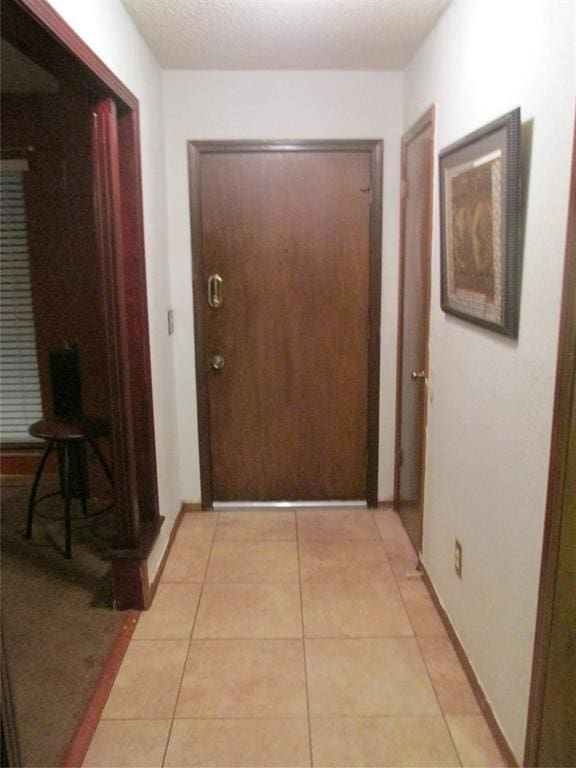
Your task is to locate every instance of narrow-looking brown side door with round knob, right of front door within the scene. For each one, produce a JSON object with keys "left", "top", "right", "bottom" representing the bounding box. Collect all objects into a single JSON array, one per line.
[{"left": 394, "top": 111, "right": 434, "bottom": 551}]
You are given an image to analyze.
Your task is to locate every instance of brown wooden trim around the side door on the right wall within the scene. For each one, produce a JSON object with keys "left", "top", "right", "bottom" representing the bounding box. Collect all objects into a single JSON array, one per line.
[{"left": 394, "top": 104, "right": 436, "bottom": 548}]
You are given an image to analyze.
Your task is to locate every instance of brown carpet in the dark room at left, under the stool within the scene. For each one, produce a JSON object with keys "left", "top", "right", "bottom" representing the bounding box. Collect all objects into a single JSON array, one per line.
[{"left": 1, "top": 476, "right": 124, "bottom": 766}]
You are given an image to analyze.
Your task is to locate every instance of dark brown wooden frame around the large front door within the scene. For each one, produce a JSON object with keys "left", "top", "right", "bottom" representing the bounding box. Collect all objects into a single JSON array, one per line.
[{"left": 188, "top": 139, "right": 383, "bottom": 509}]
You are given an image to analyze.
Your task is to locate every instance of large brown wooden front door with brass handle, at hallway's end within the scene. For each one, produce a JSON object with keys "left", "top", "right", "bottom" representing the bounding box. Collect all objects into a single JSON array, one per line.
[{"left": 191, "top": 142, "right": 379, "bottom": 502}]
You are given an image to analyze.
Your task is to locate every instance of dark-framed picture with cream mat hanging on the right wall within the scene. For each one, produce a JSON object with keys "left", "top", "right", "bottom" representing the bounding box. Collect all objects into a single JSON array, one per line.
[{"left": 439, "top": 108, "right": 520, "bottom": 338}]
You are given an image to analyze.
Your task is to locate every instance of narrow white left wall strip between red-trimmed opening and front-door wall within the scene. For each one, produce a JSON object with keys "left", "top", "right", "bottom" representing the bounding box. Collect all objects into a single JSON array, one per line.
[{"left": 44, "top": 0, "right": 181, "bottom": 577}]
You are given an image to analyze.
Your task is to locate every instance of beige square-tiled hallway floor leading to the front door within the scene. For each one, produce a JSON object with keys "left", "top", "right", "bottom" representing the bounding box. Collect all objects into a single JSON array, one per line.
[{"left": 84, "top": 508, "right": 505, "bottom": 768}]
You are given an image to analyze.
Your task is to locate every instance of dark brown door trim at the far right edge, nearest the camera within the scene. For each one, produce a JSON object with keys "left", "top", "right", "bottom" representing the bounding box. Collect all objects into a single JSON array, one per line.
[{"left": 523, "top": 106, "right": 576, "bottom": 765}]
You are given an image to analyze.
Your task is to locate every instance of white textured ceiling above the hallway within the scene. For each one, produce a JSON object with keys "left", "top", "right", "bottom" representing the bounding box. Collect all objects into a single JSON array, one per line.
[{"left": 122, "top": 0, "right": 449, "bottom": 69}]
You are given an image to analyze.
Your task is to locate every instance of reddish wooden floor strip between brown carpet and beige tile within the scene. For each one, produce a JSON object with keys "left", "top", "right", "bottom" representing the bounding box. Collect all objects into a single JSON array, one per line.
[{"left": 61, "top": 611, "right": 140, "bottom": 768}]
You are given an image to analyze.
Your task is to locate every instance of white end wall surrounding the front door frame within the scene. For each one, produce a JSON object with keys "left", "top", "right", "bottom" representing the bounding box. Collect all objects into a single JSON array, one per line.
[{"left": 164, "top": 71, "right": 403, "bottom": 501}]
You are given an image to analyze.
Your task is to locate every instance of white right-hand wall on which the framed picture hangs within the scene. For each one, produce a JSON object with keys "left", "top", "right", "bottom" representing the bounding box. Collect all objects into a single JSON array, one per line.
[{"left": 405, "top": 0, "right": 576, "bottom": 760}]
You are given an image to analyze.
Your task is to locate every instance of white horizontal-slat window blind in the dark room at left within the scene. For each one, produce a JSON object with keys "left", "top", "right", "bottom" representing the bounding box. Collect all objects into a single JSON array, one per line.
[{"left": 0, "top": 168, "right": 42, "bottom": 443}]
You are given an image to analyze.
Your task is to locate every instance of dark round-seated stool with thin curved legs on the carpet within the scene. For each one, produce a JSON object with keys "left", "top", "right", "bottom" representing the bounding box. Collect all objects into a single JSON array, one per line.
[{"left": 26, "top": 416, "right": 114, "bottom": 558}]
